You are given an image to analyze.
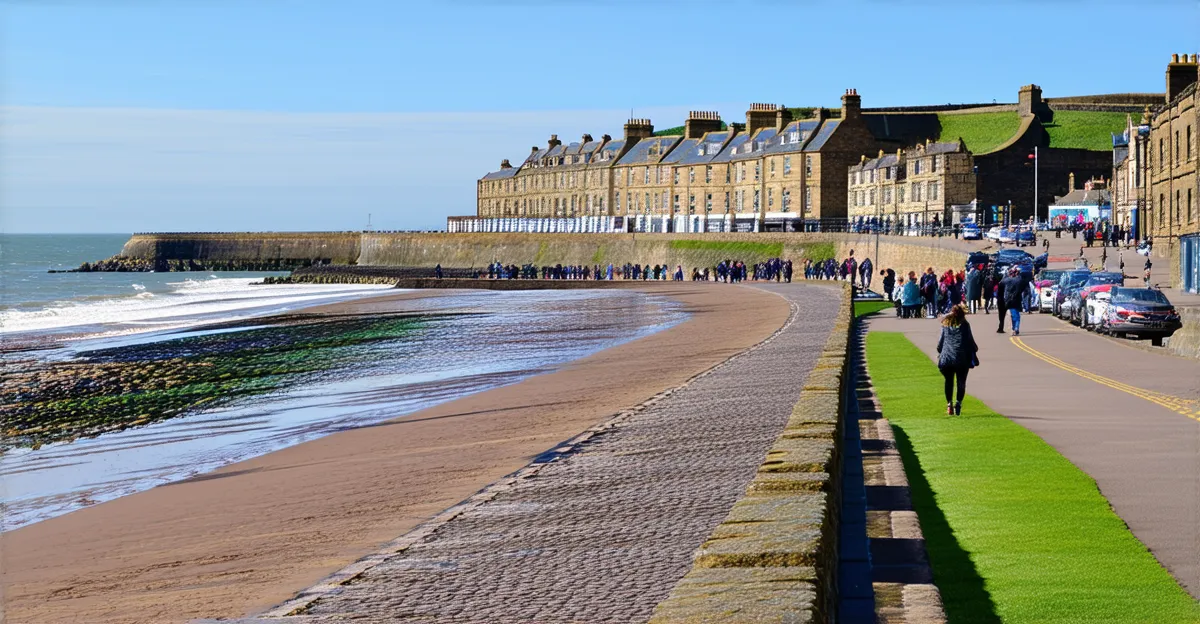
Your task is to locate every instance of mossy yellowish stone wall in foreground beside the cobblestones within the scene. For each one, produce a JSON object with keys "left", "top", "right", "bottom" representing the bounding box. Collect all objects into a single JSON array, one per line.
[{"left": 650, "top": 287, "right": 853, "bottom": 624}]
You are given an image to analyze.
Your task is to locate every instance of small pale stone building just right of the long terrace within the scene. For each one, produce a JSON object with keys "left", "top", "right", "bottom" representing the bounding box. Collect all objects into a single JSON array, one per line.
[{"left": 847, "top": 140, "right": 976, "bottom": 229}]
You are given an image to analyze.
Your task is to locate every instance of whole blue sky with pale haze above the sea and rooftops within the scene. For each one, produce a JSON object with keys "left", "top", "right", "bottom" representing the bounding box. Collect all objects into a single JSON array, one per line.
[{"left": 0, "top": 0, "right": 1200, "bottom": 233}]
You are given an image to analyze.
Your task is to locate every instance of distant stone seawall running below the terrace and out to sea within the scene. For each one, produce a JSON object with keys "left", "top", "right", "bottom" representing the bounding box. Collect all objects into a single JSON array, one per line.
[{"left": 121, "top": 232, "right": 983, "bottom": 277}]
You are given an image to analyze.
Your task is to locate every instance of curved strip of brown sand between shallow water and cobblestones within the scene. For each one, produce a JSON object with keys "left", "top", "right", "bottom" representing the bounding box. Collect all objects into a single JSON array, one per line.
[{"left": 0, "top": 283, "right": 788, "bottom": 623}]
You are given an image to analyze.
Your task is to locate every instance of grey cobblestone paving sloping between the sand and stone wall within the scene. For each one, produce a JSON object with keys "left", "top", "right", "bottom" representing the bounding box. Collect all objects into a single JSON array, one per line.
[{"left": 284, "top": 284, "right": 838, "bottom": 623}]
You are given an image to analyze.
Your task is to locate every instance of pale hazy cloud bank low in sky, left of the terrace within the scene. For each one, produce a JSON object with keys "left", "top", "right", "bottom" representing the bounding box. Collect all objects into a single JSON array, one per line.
[{"left": 0, "top": 104, "right": 744, "bottom": 232}]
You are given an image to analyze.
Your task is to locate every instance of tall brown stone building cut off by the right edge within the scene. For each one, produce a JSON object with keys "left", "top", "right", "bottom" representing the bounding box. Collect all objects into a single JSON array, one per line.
[{"left": 1142, "top": 54, "right": 1200, "bottom": 292}]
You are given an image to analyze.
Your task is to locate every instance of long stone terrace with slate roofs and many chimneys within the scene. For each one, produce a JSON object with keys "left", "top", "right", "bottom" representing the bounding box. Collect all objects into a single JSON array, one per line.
[{"left": 476, "top": 89, "right": 892, "bottom": 232}]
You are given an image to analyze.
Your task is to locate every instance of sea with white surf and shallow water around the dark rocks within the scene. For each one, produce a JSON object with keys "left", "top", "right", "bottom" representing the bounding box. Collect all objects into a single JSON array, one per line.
[{"left": 0, "top": 234, "right": 686, "bottom": 532}]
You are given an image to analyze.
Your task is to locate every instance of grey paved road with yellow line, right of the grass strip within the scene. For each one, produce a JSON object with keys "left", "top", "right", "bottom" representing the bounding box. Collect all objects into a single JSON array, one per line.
[{"left": 871, "top": 314, "right": 1200, "bottom": 598}]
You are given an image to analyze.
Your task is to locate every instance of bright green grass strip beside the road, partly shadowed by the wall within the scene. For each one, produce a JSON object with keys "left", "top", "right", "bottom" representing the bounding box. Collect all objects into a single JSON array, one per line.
[{"left": 866, "top": 332, "right": 1200, "bottom": 624}]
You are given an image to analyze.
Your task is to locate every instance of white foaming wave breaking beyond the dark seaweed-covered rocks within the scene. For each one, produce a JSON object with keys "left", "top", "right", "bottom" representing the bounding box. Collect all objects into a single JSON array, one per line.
[{"left": 0, "top": 277, "right": 390, "bottom": 334}]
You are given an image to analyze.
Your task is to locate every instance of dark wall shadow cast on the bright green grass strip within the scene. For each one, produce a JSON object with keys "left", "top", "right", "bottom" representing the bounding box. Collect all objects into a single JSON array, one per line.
[{"left": 892, "top": 422, "right": 1001, "bottom": 624}]
